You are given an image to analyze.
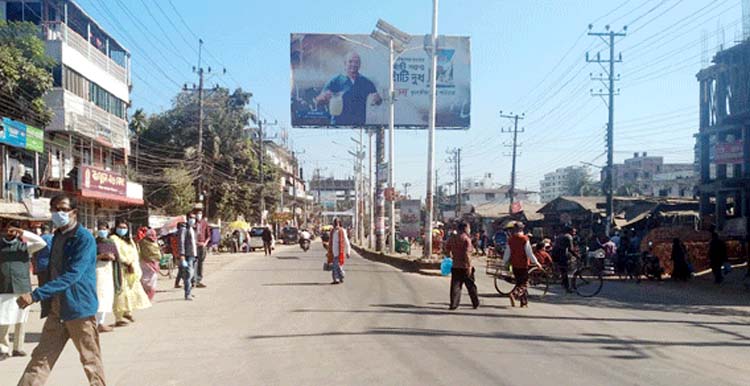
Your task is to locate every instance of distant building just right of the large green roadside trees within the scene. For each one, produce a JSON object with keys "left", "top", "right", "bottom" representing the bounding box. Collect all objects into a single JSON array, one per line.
[{"left": 265, "top": 140, "right": 312, "bottom": 226}]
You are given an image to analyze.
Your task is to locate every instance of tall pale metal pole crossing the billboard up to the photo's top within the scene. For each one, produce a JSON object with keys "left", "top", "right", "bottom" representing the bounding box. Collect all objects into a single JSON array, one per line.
[{"left": 424, "top": 0, "right": 438, "bottom": 258}]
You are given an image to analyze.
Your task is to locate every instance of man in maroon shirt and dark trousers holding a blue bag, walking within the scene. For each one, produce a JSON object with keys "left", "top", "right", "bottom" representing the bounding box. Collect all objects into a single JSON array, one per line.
[{"left": 446, "top": 222, "right": 479, "bottom": 310}]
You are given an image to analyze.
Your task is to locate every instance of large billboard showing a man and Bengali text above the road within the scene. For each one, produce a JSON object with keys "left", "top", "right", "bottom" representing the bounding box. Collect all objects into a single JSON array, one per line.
[{"left": 291, "top": 34, "right": 471, "bottom": 129}]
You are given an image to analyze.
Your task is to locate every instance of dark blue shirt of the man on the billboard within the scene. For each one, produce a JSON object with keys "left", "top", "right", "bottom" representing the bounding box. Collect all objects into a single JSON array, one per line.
[{"left": 323, "top": 75, "right": 377, "bottom": 126}]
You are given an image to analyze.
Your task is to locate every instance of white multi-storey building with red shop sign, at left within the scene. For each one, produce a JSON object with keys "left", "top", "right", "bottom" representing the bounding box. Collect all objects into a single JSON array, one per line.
[{"left": 0, "top": 0, "right": 143, "bottom": 228}]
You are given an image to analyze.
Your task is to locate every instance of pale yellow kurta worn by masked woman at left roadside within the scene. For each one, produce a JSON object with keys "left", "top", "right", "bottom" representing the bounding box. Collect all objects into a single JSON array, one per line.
[{"left": 110, "top": 235, "right": 151, "bottom": 313}]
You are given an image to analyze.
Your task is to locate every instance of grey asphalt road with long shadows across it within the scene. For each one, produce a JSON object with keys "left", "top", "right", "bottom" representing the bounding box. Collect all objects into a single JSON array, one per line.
[{"left": 0, "top": 246, "right": 750, "bottom": 386}]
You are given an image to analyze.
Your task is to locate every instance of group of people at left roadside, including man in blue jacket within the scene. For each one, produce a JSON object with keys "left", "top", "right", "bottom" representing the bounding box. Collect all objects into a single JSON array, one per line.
[{"left": 0, "top": 194, "right": 210, "bottom": 385}]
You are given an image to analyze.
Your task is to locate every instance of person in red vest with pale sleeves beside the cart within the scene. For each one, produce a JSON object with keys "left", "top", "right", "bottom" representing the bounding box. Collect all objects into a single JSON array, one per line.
[{"left": 503, "top": 221, "right": 543, "bottom": 307}]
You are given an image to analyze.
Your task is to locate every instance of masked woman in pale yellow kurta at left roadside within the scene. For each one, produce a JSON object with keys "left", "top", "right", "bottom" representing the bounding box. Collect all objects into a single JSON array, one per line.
[{"left": 109, "top": 218, "right": 151, "bottom": 327}]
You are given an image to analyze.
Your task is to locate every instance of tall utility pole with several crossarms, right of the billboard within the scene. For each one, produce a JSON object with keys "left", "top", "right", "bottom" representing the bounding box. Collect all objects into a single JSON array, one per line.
[{"left": 586, "top": 24, "right": 628, "bottom": 236}]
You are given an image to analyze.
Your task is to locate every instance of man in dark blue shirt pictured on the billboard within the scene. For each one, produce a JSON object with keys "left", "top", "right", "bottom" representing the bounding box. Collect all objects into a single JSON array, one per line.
[{"left": 315, "top": 52, "right": 383, "bottom": 126}]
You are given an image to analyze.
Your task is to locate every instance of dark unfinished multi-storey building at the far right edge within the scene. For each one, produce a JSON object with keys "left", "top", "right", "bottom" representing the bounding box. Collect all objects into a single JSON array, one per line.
[{"left": 696, "top": 40, "right": 750, "bottom": 234}]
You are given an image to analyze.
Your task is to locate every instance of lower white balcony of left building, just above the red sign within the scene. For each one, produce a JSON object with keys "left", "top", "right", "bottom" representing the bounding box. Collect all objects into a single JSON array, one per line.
[{"left": 45, "top": 88, "right": 130, "bottom": 150}]
